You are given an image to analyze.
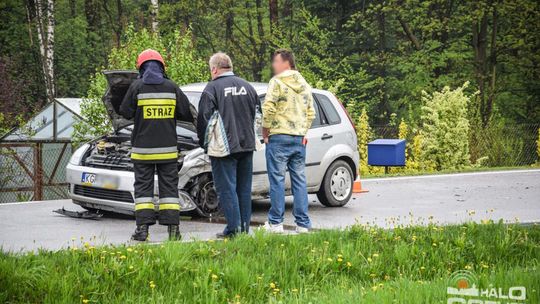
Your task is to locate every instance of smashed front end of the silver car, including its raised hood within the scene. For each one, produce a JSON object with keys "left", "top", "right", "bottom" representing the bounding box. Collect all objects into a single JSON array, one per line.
[{"left": 66, "top": 71, "right": 219, "bottom": 217}]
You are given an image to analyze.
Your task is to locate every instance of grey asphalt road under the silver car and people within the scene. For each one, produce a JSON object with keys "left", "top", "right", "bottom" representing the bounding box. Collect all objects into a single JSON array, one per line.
[{"left": 0, "top": 170, "right": 540, "bottom": 252}]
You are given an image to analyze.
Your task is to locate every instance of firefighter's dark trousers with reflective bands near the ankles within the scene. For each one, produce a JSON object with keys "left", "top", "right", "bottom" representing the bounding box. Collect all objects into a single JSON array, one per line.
[{"left": 133, "top": 162, "right": 180, "bottom": 225}]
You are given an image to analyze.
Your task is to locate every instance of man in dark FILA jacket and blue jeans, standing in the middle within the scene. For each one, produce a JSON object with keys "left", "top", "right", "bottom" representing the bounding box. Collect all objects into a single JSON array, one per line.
[{"left": 197, "top": 53, "right": 261, "bottom": 237}]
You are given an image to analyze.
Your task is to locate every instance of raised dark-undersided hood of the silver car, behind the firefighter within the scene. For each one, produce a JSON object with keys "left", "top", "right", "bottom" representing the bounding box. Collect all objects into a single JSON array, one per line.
[{"left": 102, "top": 70, "right": 197, "bottom": 132}]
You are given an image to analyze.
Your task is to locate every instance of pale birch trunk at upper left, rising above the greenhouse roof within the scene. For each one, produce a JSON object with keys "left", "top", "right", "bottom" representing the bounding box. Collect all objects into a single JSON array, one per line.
[{"left": 34, "top": 0, "right": 56, "bottom": 102}]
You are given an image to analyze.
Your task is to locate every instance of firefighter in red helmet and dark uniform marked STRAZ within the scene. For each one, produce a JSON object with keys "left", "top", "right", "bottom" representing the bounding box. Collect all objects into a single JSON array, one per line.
[{"left": 120, "top": 49, "right": 194, "bottom": 241}]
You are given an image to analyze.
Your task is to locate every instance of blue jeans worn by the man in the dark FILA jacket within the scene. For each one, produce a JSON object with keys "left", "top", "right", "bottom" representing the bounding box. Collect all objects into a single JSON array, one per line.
[{"left": 210, "top": 152, "right": 253, "bottom": 235}]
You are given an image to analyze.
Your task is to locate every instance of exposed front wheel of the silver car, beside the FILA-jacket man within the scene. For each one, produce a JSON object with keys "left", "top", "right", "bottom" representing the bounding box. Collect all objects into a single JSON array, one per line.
[{"left": 195, "top": 173, "right": 223, "bottom": 218}]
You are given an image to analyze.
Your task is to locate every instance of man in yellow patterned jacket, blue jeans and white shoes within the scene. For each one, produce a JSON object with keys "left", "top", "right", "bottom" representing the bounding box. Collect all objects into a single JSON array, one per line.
[{"left": 262, "top": 49, "right": 315, "bottom": 233}]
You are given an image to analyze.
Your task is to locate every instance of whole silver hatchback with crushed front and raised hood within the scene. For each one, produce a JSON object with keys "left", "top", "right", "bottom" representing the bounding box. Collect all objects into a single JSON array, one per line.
[{"left": 66, "top": 71, "right": 359, "bottom": 217}]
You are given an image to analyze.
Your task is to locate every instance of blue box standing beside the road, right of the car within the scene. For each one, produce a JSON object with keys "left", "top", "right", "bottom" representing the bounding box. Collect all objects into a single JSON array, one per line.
[{"left": 368, "top": 139, "right": 405, "bottom": 167}]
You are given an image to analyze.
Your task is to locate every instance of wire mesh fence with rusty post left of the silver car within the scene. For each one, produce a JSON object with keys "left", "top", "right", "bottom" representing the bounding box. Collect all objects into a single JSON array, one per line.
[{"left": 0, "top": 142, "right": 72, "bottom": 203}]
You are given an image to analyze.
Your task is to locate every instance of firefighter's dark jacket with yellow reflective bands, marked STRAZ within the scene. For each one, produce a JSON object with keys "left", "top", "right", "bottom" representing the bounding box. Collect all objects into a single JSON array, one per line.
[{"left": 120, "top": 78, "right": 194, "bottom": 163}]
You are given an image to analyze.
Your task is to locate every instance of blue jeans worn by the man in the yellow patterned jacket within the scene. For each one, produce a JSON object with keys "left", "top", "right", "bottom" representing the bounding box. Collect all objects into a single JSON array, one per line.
[{"left": 266, "top": 134, "right": 311, "bottom": 228}]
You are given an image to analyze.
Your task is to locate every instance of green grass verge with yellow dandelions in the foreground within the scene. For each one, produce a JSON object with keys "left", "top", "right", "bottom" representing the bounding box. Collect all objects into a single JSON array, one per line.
[{"left": 0, "top": 223, "right": 540, "bottom": 303}]
